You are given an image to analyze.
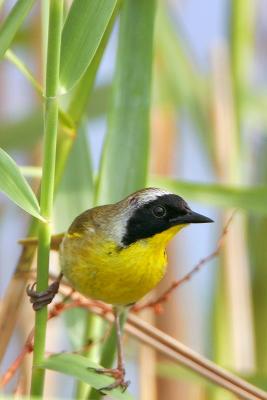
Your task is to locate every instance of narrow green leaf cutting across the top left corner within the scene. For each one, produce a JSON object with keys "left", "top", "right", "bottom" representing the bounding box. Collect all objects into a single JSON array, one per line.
[{"left": 0, "top": 0, "right": 35, "bottom": 59}]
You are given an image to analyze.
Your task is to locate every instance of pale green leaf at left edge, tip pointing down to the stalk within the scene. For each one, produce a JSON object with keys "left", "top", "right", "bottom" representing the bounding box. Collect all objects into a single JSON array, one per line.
[{"left": 0, "top": 148, "right": 44, "bottom": 221}]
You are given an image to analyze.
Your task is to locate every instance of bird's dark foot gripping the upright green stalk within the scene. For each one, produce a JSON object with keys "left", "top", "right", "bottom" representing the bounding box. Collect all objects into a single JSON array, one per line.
[{"left": 26, "top": 280, "right": 60, "bottom": 311}]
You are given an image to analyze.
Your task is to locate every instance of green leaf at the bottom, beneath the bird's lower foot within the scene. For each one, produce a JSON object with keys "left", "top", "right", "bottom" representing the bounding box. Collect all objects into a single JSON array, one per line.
[{"left": 40, "top": 353, "right": 133, "bottom": 400}]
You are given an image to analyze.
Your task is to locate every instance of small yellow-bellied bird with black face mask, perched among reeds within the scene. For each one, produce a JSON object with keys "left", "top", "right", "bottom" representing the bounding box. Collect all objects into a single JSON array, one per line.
[{"left": 27, "top": 188, "right": 213, "bottom": 390}]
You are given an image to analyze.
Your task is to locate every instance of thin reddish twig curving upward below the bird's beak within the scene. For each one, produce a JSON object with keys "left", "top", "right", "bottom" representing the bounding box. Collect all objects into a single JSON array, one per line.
[{"left": 132, "top": 211, "right": 236, "bottom": 313}]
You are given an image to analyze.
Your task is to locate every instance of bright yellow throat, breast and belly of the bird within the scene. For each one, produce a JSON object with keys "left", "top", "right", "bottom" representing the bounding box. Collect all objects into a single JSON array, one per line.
[{"left": 60, "top": 225, "right": 183, "bottom": 305}]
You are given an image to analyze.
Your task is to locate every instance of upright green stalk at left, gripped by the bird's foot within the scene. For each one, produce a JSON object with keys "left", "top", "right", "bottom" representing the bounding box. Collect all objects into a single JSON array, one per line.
[{"left": 31, "top": 0, "right": 63, "bottom": 396}]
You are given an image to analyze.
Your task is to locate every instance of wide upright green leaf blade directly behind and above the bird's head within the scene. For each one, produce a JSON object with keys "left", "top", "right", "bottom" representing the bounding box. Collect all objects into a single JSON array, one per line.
[{"left": 97, "top": 0, "right": 156, "bottom": 204}]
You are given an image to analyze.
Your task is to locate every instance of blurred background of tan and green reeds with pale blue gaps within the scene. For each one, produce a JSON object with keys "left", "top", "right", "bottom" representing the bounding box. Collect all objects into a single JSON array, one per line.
[{"left": 0, "top": 0, "right": 267, "bottom": 400}]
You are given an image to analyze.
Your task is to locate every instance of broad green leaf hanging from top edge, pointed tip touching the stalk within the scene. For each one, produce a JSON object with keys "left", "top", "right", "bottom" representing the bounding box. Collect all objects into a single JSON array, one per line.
[{"left": 60, "top": 0, "right": 117, "bottom": 93}]
